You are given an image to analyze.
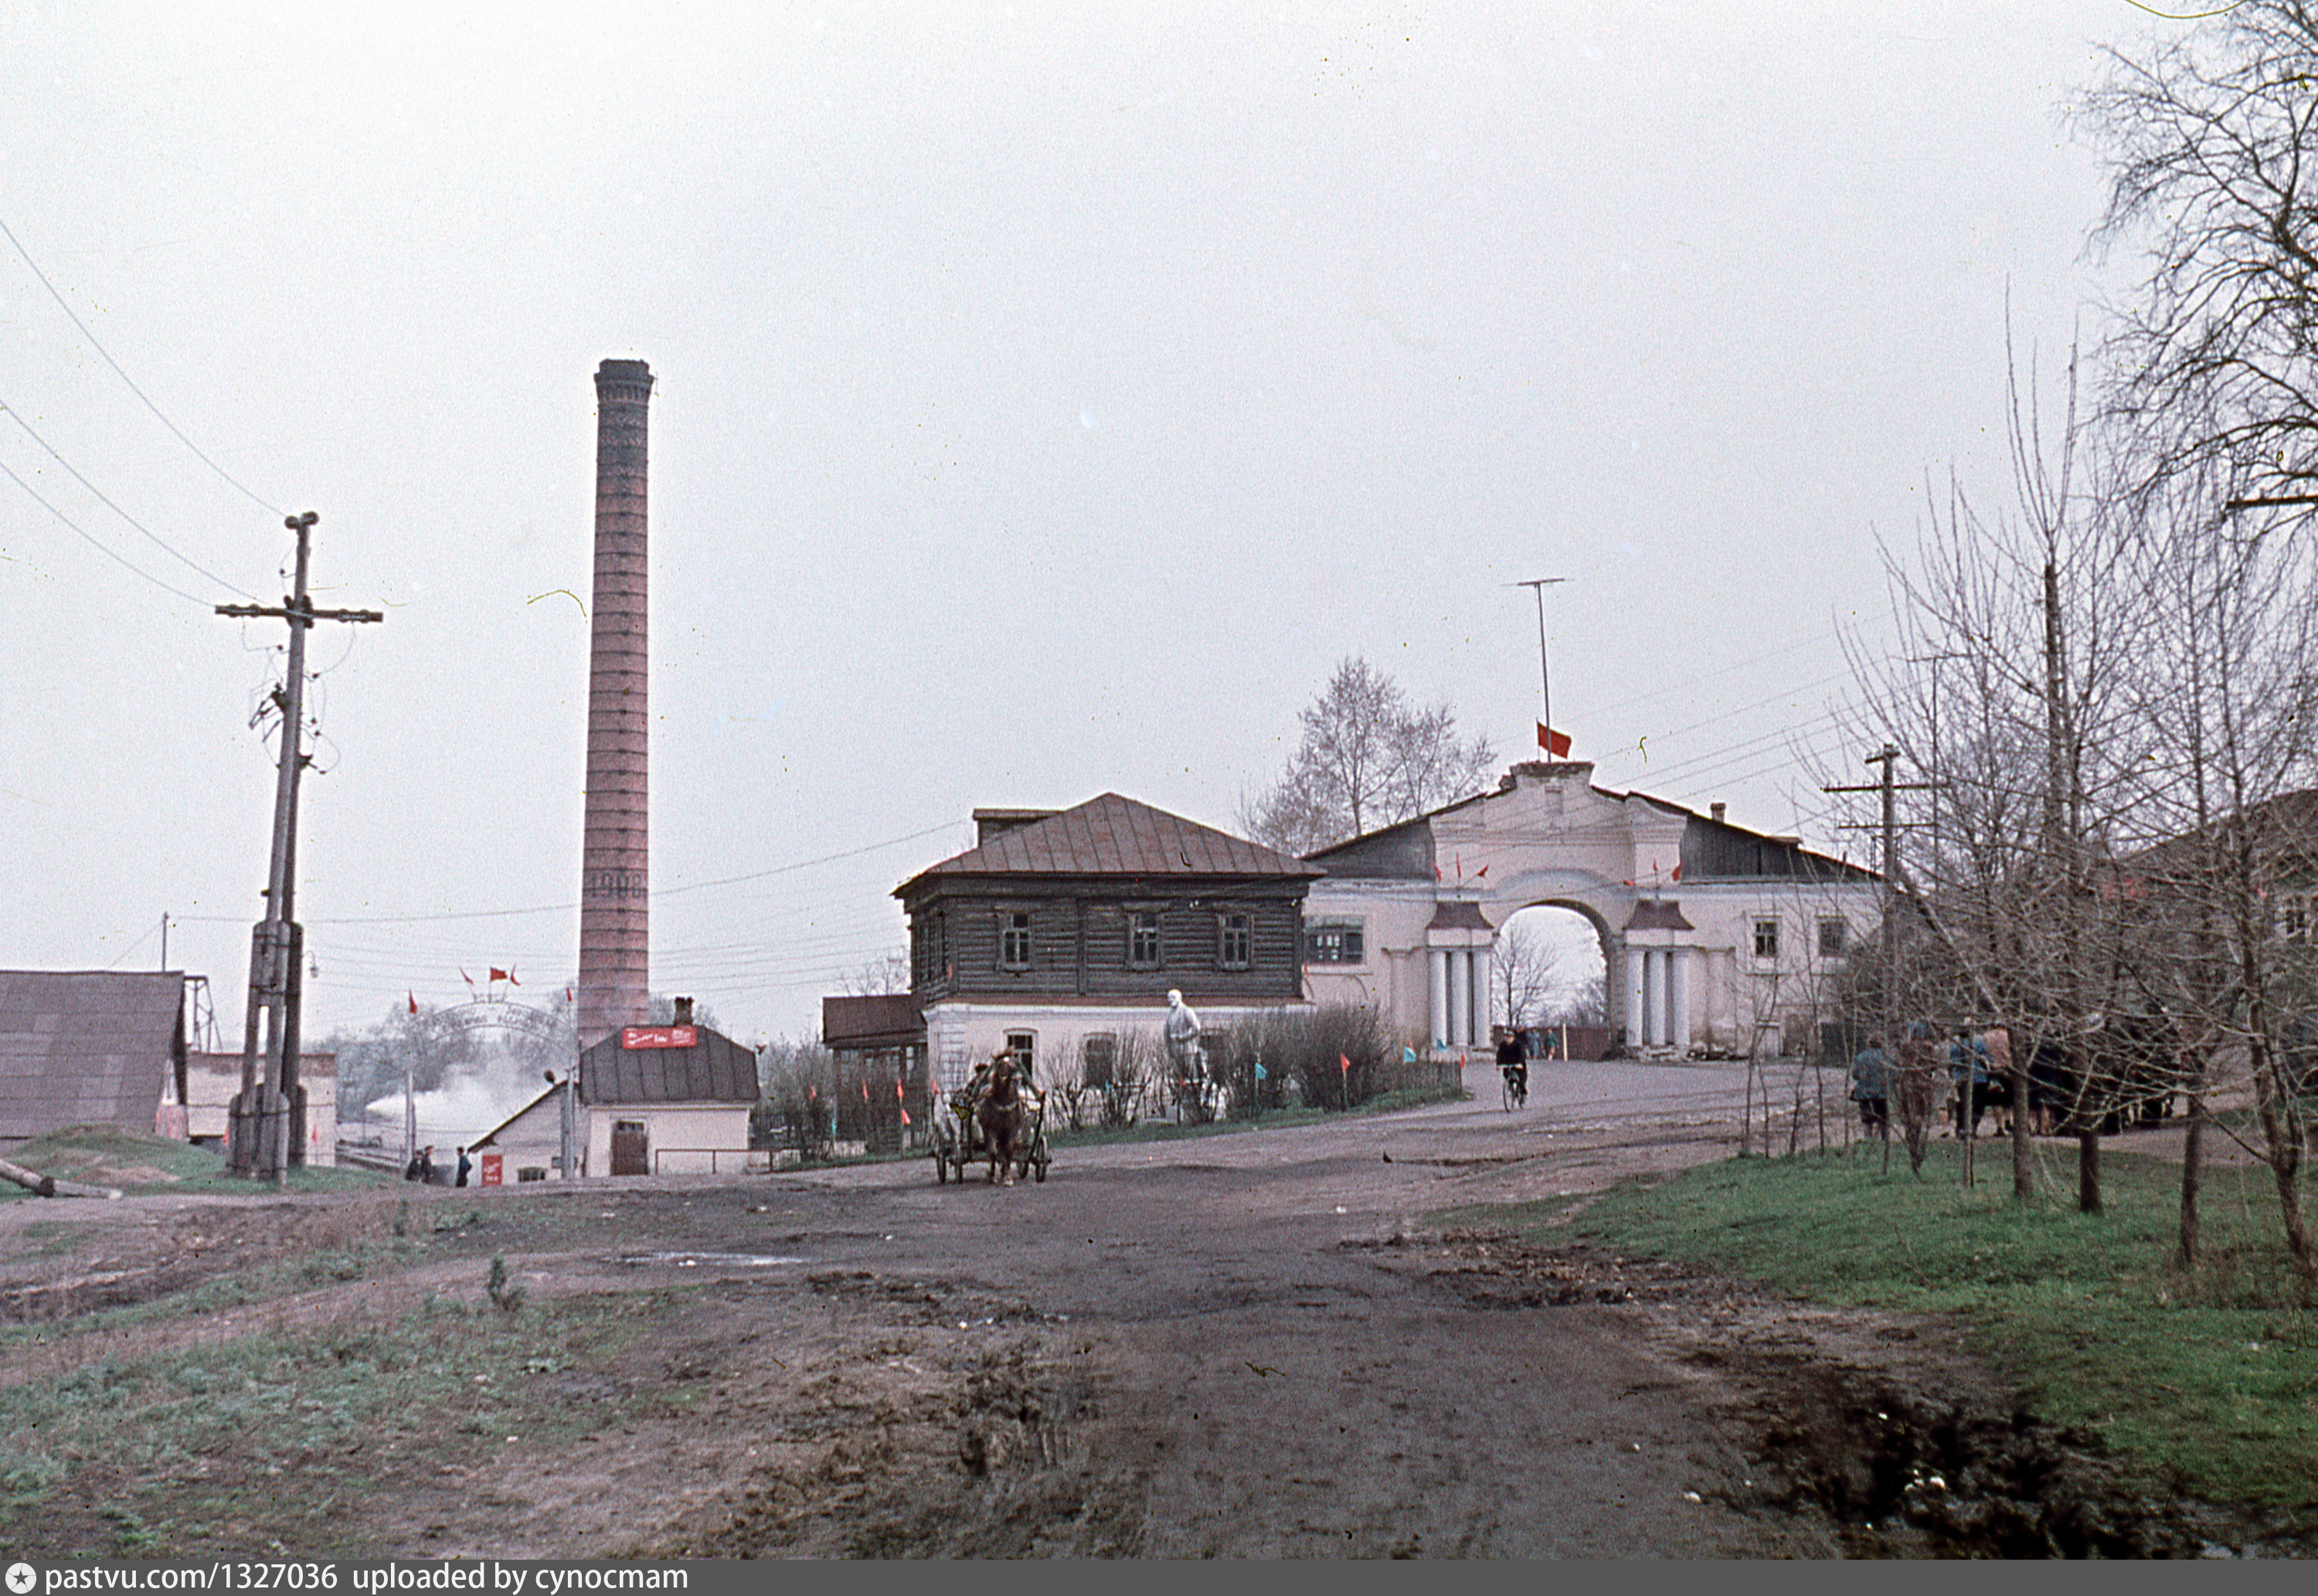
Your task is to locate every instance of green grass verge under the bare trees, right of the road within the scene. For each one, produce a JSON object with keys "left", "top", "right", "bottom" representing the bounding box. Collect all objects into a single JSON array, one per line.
[{"left": 1449, "top": 1144, "right": 2318, "bottom": 1529}]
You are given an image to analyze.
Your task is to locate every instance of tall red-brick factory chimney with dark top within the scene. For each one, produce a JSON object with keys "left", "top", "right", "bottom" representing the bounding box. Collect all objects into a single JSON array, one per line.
[{"left": 580, "top": 362, "right": 651, "bottom": 1047}]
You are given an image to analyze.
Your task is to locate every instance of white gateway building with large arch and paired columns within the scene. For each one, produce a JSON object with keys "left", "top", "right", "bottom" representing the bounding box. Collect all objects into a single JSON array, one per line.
[{"left": 1305, "top": 762, "right": 1882, "bottom": 1058}]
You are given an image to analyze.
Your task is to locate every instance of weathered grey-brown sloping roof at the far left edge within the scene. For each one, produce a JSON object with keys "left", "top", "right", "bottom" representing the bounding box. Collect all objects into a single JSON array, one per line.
[{"left": 0, "top": 970, "right": 185, "bottom": 1142}]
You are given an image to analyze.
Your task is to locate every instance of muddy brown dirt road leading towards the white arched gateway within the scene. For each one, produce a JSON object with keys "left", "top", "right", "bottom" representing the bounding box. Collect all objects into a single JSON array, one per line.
[{"left": 0, "top": 1065, "right": 2281, "bottom": 1557}]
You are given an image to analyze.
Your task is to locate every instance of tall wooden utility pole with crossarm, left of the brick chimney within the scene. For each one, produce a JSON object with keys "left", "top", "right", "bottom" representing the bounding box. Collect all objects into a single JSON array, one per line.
[{"left": 218, "top": 510, "right": 385, "bottom": 1186}]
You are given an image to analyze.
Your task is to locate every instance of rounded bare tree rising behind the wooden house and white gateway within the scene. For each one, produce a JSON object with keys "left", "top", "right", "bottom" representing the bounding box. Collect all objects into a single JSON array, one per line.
[{"left": 1240, "top": 658, "right": 1497, "bottom": 854}]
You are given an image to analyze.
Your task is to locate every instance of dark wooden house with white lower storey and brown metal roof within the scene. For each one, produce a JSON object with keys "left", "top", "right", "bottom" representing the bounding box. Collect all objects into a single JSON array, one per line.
[{"left": 895, "top": 793, "right": 1319, "bottom": 1091}]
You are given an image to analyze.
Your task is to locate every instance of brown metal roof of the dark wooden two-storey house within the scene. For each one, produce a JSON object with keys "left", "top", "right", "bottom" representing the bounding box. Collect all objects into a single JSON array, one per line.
[{"left": 892, "top": 793, "right": 1321, "bottom": 896}]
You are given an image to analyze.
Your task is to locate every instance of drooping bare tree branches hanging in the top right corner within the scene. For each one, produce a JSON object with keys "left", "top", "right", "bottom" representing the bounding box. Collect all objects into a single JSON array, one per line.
[{"left": 2077, "top": 0, "right": 2318, "bottom": 517}]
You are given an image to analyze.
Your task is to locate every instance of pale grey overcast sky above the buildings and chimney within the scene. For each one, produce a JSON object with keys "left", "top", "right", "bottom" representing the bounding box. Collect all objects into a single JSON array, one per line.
[{"left": 0, "top": 0, "right": 2184, "bottom": 1047}]
